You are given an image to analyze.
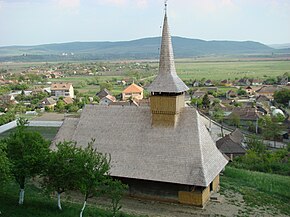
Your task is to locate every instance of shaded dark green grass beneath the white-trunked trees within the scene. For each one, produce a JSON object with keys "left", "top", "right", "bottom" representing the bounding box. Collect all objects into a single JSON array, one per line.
[{"left": 0, "top": 183, "right": 139, "bottom": 217}]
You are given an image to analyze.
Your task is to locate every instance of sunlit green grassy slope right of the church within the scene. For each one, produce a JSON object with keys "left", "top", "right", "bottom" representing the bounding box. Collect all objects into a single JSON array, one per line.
[{"left": 221, "top": 167, "right": 290, "bottom": 215}]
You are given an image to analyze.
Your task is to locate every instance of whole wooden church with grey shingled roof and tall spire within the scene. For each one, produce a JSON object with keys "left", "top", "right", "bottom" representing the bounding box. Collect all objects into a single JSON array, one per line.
[{"left": 54, "top": 7, "right": 227, "bottom": 207}]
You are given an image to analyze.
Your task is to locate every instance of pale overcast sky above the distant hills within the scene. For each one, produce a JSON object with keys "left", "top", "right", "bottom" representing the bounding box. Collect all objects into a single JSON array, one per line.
[{"left": 0, "top": 0, "right": 290, "bottom": 46}]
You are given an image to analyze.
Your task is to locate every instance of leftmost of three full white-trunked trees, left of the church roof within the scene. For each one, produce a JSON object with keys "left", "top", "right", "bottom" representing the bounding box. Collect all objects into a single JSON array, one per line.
[{"left": 3, "top": 118, "right": 49, "bottom": 205}]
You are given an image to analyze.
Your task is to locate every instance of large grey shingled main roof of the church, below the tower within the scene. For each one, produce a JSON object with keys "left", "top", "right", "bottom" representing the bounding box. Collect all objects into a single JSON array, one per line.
[{"left": 54, "top": 105, "right": 227, "bottom": 186}]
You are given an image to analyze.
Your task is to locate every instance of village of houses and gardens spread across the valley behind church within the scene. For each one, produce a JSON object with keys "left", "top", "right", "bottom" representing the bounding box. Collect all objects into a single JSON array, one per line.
[{"left": 0, "top": 63, "right": 290, "bottom": 157}]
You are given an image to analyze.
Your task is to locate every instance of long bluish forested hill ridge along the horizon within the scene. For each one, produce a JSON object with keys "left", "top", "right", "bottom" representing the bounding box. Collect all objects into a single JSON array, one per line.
[{"left": 0, "top": 37, "right": 275, "bottom": 61}]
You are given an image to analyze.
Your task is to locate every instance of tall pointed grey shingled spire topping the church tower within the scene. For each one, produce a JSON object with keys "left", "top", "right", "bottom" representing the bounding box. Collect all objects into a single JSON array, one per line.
[{"left": 148, "top": 6, "right": 189, "bottom": 93}]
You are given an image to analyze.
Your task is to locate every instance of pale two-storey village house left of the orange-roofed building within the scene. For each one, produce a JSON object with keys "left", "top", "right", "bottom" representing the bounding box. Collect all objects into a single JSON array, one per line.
[{"left": 50, "top": 83, "right": 74, "bottom": 98}]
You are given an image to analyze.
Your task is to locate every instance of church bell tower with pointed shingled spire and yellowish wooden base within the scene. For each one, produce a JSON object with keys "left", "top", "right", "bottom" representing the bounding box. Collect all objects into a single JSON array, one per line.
[{"left": 148, "top": 3, "right": 189, "bottom": 127}]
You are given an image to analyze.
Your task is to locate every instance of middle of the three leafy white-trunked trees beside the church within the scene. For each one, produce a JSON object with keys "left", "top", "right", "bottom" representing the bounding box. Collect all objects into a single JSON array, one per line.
[{"left": 43, "top": 141, "right": 80, "bottom": 210}]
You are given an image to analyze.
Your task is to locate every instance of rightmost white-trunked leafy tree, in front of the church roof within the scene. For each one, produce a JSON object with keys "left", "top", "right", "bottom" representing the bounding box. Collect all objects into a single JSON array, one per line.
[{"left": 78, "top": 140, "right": 111, "bottom": 217}]
